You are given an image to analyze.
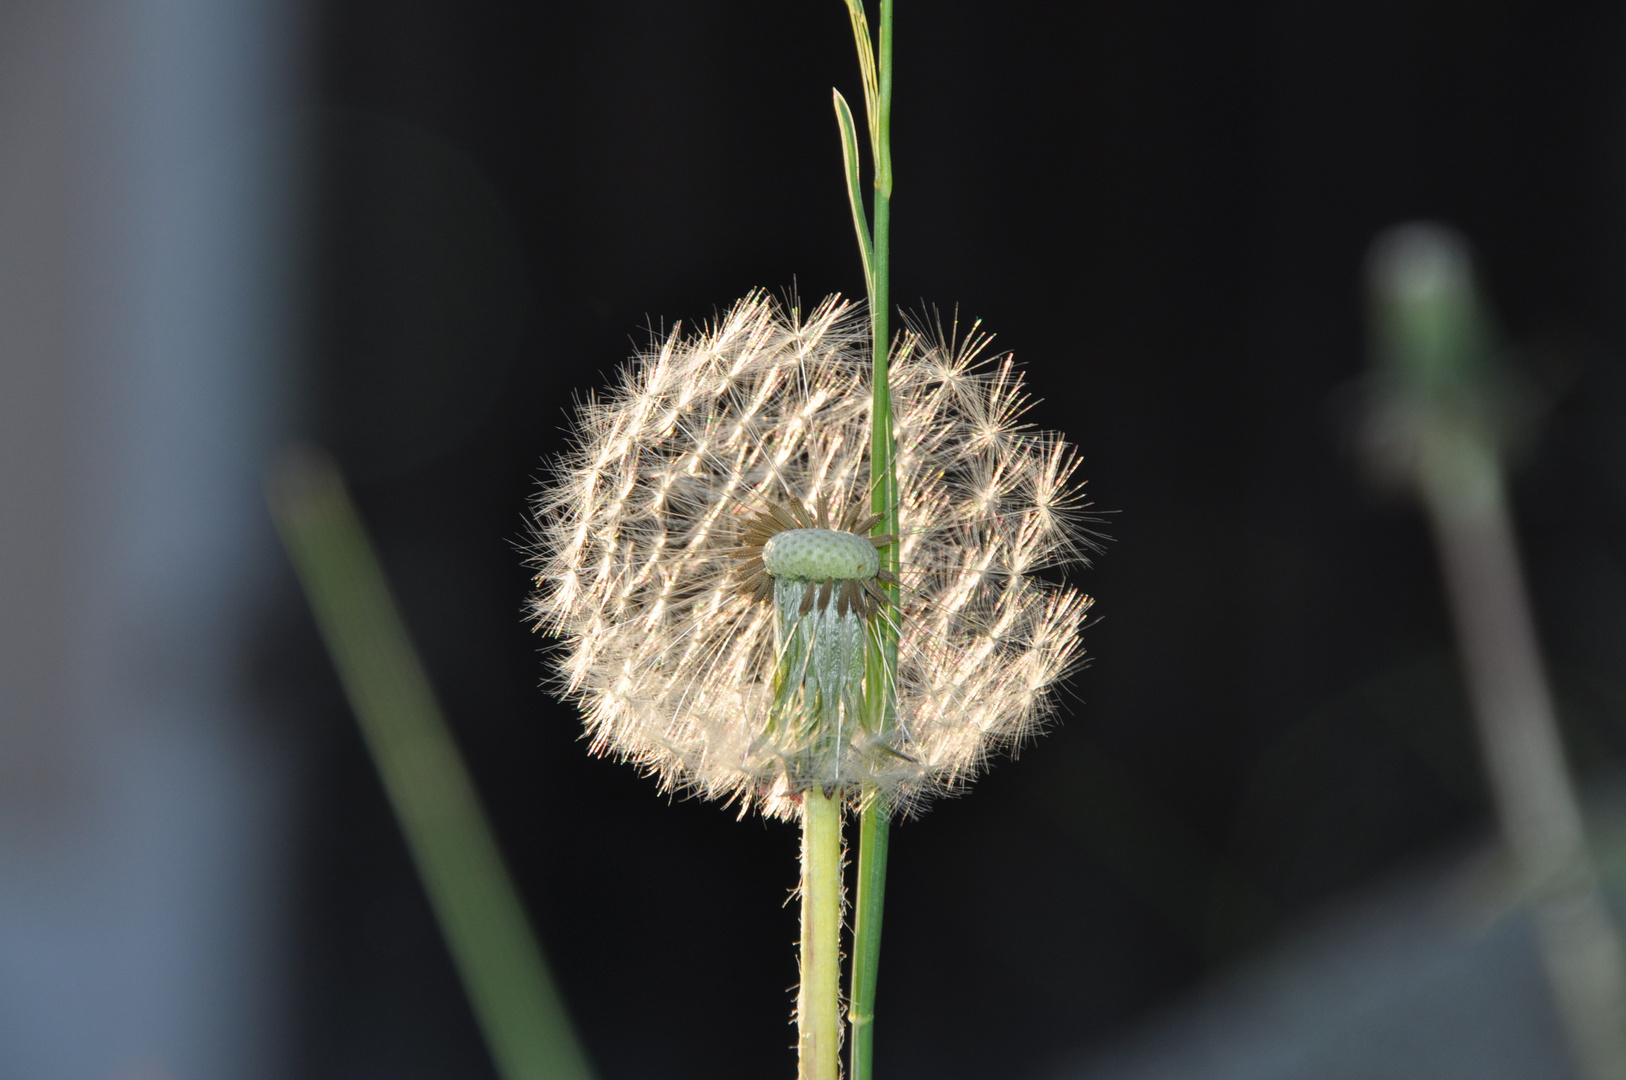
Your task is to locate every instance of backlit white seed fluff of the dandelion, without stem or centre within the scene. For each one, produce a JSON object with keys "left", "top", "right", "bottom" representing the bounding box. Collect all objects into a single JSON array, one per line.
[{"left": 533, "top": 293, "right": 1091, "bottom": 817}]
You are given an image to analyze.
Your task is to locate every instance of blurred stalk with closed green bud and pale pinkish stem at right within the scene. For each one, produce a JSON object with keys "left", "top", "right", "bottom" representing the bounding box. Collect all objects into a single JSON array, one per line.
[{"left": 1367, "top": 223, "right": 1626, "bottom": 1080}]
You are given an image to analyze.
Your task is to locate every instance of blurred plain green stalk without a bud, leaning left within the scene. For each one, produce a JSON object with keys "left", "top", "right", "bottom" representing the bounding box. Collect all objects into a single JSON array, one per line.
[{"left": 270, "top": 447, "right": 592, "bottom": 1080}]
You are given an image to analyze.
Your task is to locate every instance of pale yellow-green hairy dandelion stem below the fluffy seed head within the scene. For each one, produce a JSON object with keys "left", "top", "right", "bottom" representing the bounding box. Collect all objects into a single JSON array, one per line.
[{"left": 797, "top": 787, "right": 841, "bottom": 1080}]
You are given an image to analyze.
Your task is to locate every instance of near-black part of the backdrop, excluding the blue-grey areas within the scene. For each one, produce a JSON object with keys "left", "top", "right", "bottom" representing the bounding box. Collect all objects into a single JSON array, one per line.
[{"left": 262, "top": 0, "right": 1626, "bottom": 1080}]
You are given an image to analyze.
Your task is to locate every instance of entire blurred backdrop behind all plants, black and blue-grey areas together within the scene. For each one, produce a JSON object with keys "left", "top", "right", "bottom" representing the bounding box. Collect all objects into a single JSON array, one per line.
[{"left": 0, "top": 0, "right": 1626, "bottom": 1080}]
